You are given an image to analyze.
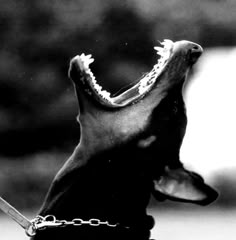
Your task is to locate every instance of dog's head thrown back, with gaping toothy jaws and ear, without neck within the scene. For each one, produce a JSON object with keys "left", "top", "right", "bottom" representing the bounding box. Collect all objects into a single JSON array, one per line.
[{"left": 69, "top": 40, "right": 217, "bottom": 204}]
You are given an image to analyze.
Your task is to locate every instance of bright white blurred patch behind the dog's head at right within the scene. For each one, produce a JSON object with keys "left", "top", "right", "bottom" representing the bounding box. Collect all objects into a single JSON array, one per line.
[{"left": 181, "top": 48, "right": 236, "bottom": 178}]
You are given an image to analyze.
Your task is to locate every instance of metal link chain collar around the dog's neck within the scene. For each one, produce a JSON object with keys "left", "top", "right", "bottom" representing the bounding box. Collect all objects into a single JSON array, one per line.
[{"left": 31, "top": 215, "right": 119, "bottom": 231}]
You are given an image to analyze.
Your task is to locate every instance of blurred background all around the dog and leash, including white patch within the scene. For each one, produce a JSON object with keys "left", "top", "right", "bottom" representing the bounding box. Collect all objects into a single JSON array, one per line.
[{"left": 0, "top": 0, "right": 236, "bottom": 240}]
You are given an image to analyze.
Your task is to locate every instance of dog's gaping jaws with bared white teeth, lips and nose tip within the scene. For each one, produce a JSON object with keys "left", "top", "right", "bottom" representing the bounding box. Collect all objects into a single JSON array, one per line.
[{"left": 69, "top": 39, "right": 202, "bottom": 108}]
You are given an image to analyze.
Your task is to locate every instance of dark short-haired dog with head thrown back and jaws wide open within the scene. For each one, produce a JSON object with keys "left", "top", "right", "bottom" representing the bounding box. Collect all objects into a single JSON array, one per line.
[{"left": 32, "top": 40, "right": 218, "bottom": 240}]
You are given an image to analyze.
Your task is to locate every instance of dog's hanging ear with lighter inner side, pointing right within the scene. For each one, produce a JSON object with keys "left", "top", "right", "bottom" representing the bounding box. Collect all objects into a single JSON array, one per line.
[{"left": 153, "top": 167, "right": 218, "bottom": 205}]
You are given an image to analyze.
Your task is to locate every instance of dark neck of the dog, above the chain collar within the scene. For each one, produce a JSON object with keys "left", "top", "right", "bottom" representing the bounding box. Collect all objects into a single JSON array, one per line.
[{"left": 40, "top": 116, "right": 153, "bottom": 225}]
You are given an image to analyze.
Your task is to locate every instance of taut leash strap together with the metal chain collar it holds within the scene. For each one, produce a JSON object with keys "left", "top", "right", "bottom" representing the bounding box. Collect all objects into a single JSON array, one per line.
[{"left": 0, "top": 197, "right": 121, "bottom": 237}]
